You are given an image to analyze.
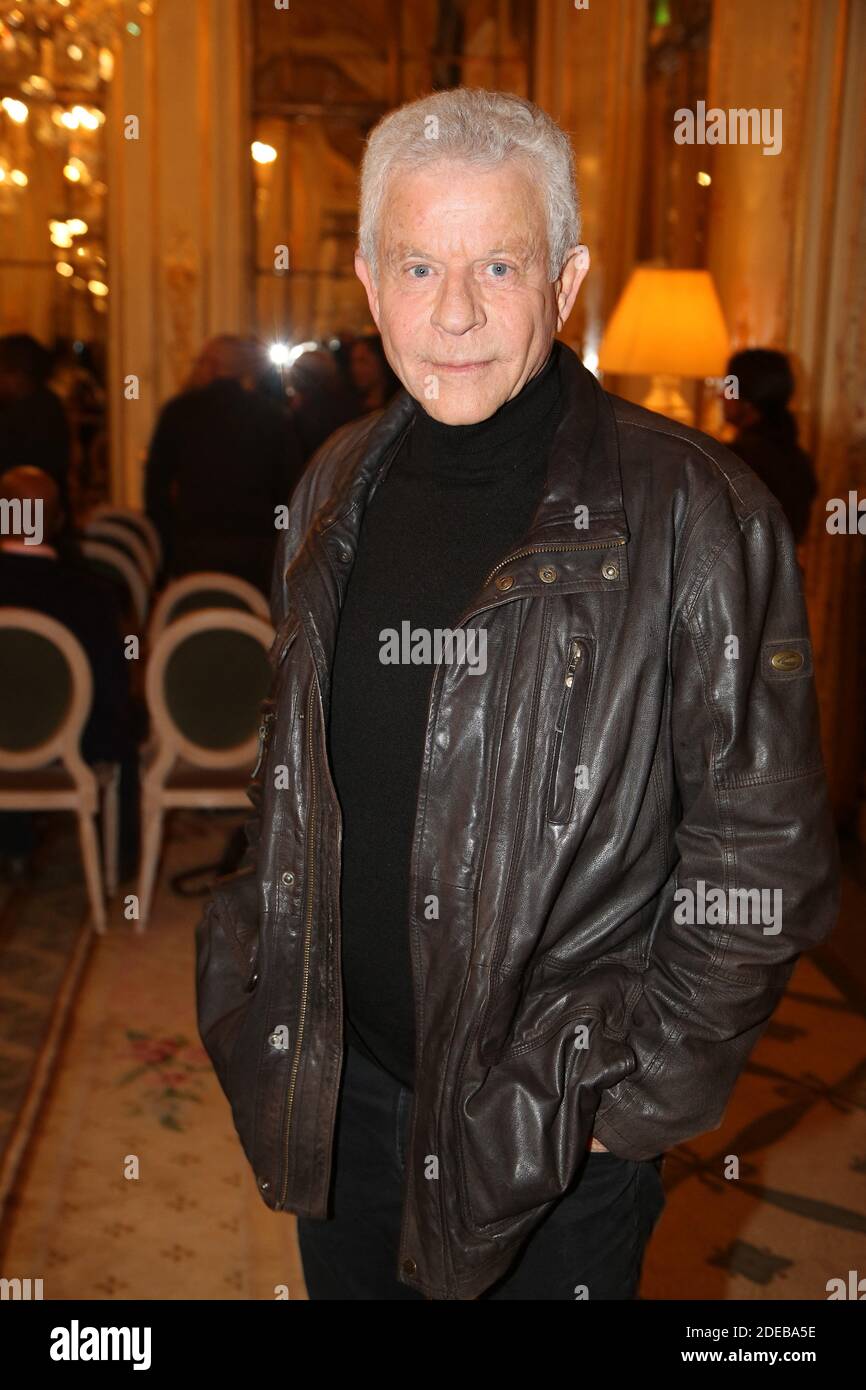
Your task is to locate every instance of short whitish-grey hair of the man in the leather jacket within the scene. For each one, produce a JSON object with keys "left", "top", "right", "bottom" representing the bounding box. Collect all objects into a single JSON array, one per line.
[{"left": 359, "top": 88, "right": 581, "bottom": 281}]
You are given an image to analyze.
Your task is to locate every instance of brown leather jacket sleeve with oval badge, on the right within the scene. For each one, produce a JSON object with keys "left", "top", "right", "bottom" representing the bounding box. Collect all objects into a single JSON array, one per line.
[{"left": 594, "top": 480, "right": 840, "bottom": 1159}]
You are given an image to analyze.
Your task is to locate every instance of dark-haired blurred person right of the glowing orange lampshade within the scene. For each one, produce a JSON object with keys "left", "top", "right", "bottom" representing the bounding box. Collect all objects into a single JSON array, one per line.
[{"left": 723, "top": 348, "right": 817, "bottom": 545}]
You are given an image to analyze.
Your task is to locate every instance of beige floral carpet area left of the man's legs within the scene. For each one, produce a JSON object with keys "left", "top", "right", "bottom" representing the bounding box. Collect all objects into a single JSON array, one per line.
[{"left": 0, "top": 813, "right": 306, "bottom": 1300}]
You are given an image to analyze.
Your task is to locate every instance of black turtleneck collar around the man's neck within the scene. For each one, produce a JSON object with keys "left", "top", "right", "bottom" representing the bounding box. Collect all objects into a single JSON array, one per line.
[{"left": 409, "top": 342, "right": 559, "bottom": 481}]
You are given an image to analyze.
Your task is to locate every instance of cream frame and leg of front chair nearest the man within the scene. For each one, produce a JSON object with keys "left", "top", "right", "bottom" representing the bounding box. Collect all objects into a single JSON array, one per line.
[{"left": 135, "top": 609, "right": 274, "bottom": 931}]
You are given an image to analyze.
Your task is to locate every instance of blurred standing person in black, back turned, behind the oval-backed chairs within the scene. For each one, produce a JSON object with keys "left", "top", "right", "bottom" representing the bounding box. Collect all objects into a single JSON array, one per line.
[{"left": 145, "top": 334, "right": 303, "bottom": 592}]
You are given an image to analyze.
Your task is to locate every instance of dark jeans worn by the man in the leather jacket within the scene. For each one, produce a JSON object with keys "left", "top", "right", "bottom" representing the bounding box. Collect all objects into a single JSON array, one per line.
[{"left": 297, "top": 1047, "right": 666, "bottom": 1300}]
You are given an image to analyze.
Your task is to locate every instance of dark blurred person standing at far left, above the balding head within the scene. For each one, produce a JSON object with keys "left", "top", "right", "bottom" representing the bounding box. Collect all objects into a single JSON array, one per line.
[{"left": 0, "top": 334, "right": 71, "bottom": 517}]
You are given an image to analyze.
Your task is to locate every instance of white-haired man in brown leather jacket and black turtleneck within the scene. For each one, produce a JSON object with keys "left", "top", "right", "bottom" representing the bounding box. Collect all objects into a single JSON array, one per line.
[{"left": 197, "top": 89, "right": 838, "bottom": 1300}]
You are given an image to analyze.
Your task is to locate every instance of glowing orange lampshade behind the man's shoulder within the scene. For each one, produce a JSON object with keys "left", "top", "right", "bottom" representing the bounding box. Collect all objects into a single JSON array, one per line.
[{"left": 599, "top": 267, "right": 730, "bottom": 377}]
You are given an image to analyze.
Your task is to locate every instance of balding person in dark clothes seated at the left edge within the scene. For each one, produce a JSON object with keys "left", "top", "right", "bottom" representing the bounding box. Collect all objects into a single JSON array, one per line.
[{"left": 0, "top": 466, "right": 145, "bottom": 877}]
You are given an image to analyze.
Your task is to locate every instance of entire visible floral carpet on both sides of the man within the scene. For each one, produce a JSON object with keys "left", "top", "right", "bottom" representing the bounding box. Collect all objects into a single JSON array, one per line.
[{"left": 0, "top": 813, "right": 866, "bottom": 1300}]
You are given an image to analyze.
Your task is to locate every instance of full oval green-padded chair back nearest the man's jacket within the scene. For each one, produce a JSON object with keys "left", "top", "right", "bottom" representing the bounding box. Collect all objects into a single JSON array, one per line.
[{"left": 146, "top": 609, "right": 274, "bottom": 769}]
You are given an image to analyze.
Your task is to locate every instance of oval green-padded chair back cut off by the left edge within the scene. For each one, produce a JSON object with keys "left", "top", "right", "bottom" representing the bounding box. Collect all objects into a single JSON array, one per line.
[{"left": 0, "top": 607, "right": 93, "bottom": 771}]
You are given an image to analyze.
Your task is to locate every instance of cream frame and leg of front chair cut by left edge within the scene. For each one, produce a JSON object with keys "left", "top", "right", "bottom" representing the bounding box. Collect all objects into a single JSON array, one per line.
[{"left": 0, "top": 607, "right": 117, "bottom": 933}]
